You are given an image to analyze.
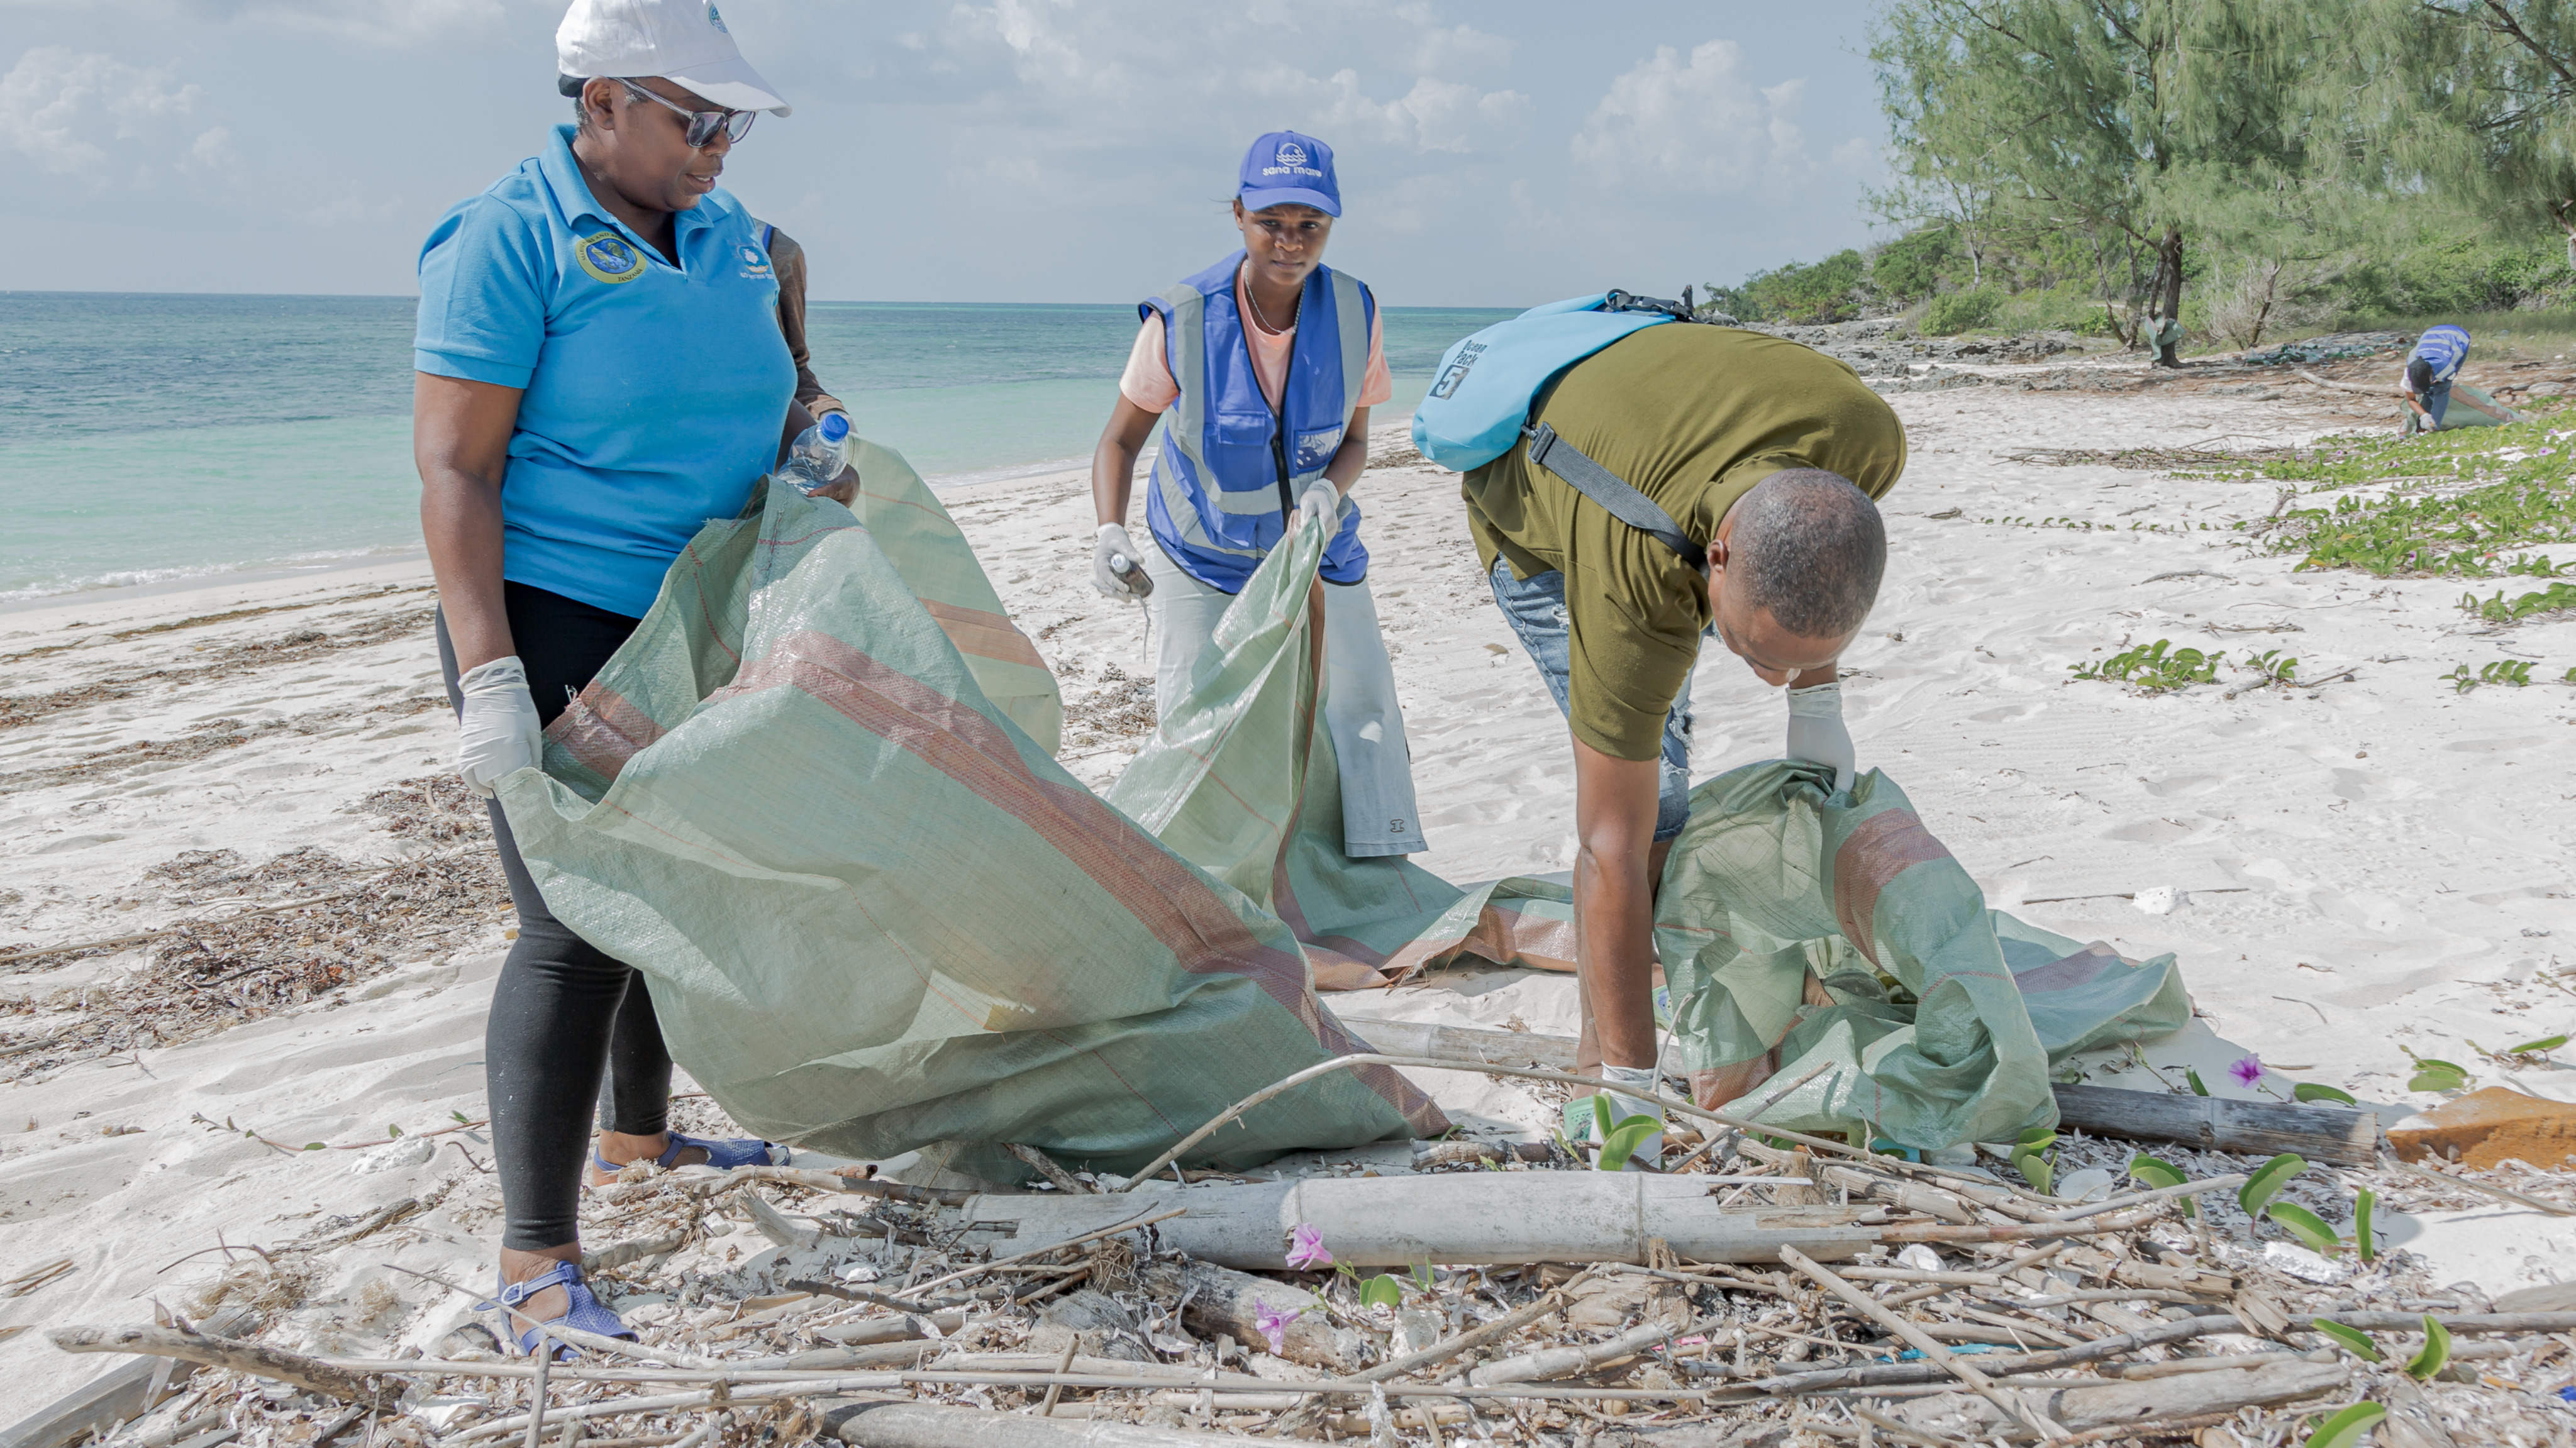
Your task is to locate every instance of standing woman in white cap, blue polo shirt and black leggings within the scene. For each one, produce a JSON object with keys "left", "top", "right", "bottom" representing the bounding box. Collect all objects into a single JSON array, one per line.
[{"left": 412, "top": 0, "right": 829, "bottom": 1350}]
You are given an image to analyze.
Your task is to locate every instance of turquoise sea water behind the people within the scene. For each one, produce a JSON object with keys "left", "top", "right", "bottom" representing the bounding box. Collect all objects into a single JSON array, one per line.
[{"left": 0, "top": 291, "right": 1509, "bottom": 600}]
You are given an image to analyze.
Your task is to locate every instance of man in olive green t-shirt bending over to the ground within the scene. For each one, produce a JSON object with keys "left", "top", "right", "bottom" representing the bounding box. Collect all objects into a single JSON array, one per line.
[{"left": 1463, "top": 324, "right": 1906, "bottom": 1154}]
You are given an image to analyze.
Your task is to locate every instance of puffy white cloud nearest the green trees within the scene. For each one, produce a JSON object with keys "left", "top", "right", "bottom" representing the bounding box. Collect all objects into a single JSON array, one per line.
[{"left": 1574, "top": 41, "right": 1814, "bottom": 196}]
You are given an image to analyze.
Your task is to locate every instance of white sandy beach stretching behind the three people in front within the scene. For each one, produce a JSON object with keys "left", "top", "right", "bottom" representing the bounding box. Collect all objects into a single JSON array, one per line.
[{"left": 0, "top": 363, "right": 2576, "bottom": 1422}]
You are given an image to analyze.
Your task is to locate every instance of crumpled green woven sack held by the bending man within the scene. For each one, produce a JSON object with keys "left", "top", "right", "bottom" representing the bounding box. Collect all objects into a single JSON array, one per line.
[{"left": 1657, "top": 760, "right": 2192, "bottom": 1149}]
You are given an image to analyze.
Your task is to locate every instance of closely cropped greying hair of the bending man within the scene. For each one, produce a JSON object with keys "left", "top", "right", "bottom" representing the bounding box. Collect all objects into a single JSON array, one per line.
[{"left": 1731, "top": 467, "right": 1888, "bottom": 639}]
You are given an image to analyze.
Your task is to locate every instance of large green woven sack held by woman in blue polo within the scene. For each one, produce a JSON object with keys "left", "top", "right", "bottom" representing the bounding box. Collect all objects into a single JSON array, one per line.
[{"left": 500, "top": 468, "right": 1448, "bottom": 1180}]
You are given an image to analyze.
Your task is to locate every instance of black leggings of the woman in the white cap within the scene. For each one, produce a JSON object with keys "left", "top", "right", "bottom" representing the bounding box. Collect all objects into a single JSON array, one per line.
[{"left": 438, "top": 582, "right": 670, "bottom": 1252}]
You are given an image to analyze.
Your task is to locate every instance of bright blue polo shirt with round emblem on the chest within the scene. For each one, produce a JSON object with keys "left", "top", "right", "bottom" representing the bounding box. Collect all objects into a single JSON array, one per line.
[{"left": 412, "top": 126, "right": 796, "bottom": 618}]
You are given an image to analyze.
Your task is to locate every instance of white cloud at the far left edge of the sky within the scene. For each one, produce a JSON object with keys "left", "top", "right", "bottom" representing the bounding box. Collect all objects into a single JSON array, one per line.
[{"left": 0, "top": 47, "right": 203, "bottom": 178}]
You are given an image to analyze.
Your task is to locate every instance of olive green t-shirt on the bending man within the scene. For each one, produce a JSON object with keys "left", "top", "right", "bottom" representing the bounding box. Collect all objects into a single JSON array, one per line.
[{"left": 1463, "top": 324, "right": 1906, "bottom": 760}]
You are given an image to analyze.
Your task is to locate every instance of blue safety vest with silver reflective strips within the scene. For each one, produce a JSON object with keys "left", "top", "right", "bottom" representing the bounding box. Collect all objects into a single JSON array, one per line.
[{"left": 1136, "top": 253, "right": 1378, "bottom": 593}]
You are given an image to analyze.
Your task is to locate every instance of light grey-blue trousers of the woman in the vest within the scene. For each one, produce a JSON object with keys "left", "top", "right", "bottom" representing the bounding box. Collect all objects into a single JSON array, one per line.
[{"left": 1144, "top": 546, "right": 1430, "bottom": 861}]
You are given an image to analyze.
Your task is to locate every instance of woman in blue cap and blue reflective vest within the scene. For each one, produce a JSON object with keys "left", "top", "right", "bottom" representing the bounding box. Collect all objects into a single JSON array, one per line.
[{"left": 1092, "top": 131, "right": 1424, "bottom": 858}]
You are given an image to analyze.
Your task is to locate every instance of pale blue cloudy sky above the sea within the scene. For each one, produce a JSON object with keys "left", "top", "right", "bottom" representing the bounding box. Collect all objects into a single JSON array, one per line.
[{"left": 0, "top": 0, "right": 1883, "bottom": 307}]
